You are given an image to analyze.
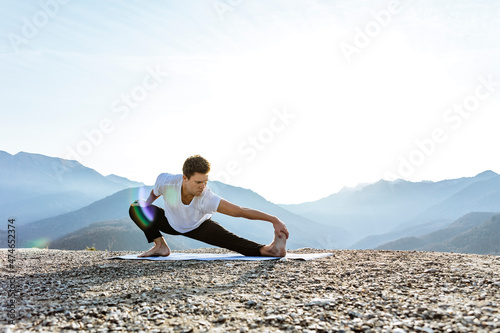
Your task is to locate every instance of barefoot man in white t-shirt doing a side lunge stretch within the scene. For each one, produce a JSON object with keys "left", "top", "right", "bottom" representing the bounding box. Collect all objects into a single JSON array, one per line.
[{"left": 129, "top": 155, "right": 289, "bottom": 257}]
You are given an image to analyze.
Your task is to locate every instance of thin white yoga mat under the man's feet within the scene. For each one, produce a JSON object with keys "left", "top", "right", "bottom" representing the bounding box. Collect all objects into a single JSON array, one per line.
[{"left": 106, "top": 252, "right": 333, "bottom": 261}]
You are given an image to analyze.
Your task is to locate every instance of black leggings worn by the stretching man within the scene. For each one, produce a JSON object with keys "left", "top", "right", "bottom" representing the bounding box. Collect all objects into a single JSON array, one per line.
[{"left": 129, "top": 206, "right": 264, "bottom": 256}]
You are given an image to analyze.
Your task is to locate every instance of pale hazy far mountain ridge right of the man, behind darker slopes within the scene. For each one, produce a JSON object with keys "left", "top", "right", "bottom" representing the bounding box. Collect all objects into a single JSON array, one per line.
[{"left": 281, "top": 171, "right": 500, "bottom": 249}]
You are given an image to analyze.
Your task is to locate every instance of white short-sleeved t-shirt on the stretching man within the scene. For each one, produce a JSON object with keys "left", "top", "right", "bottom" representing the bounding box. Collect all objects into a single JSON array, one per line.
[{"left": 153, "top": 173, "right": 221, "bottom": 233}]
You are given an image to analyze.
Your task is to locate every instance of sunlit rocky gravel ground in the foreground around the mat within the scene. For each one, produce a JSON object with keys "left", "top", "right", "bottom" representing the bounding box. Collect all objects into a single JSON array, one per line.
[{"left": 1, "top": 249, "right": 500, "bottom": 332}]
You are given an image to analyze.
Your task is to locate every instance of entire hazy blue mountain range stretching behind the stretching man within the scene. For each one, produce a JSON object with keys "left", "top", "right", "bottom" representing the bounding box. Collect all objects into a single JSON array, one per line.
[{"left": 0, "top": 151, "right": 500, "bottom": 253}]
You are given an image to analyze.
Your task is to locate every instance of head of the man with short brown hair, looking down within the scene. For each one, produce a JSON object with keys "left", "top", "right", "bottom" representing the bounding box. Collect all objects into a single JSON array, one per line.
[{"left": 182, "top": 155, "right": 210, "bottom": 195}]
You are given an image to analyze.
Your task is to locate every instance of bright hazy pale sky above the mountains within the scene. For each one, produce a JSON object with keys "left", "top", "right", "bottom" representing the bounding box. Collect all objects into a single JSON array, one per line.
[{"left": 0, "top": 0, "right": 500, "bottom": 203}]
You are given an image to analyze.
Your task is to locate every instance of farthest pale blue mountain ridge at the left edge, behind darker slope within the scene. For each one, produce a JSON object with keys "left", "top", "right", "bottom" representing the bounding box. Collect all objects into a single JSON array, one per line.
[{"left": 0, "top": 151, "right": 144, "bottom": 225}]
